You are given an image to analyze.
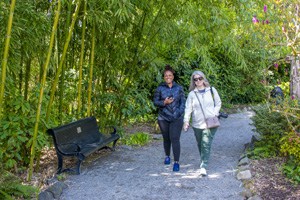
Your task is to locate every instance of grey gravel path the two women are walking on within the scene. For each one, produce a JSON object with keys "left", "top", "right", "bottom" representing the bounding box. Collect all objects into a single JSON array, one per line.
[{"left": 60, "top": 112, "right": 253, "bottom": 200}]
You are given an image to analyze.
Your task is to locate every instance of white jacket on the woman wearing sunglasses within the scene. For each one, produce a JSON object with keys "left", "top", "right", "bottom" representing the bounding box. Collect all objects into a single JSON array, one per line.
[{"left": 184, "top": 87, "right": 222, "bottom": 129}]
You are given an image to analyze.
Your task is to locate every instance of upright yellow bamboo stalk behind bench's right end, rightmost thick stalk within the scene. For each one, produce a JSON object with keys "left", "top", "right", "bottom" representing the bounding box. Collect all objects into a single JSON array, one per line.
[{"left": 87, "top": 22, "right": 95, "bottom": 116}]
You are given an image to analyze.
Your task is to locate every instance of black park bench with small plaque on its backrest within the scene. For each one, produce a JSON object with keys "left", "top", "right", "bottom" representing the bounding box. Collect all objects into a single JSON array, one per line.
[{"left": 47, "top": 117, "right": 120, "bottom": 174}]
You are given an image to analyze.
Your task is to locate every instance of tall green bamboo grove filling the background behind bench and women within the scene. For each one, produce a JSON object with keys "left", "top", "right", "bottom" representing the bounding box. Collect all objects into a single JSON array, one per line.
[{"left": 0, "top": 0, "right": 298, "bottom": 179}]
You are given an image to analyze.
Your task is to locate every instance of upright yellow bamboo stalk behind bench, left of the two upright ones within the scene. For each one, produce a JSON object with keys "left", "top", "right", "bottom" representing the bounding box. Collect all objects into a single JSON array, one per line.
[{"left": 77, "top": 0, "right": 87, "bottom": 116}]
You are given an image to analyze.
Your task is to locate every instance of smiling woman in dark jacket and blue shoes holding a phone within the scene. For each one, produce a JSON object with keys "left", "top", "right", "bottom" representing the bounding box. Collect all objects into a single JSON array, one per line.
[{"left": 154, "top": 65, "right": 185, "bottom": 171}]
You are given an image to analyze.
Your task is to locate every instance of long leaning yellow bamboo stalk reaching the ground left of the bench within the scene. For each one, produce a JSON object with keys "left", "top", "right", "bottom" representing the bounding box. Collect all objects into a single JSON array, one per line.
[{"left": 27, "top": 0, "right": 61, "bottom": 181}]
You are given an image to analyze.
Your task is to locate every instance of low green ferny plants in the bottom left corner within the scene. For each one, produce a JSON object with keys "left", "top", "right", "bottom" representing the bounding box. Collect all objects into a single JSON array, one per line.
[{"left": 0, "top": 169, "right": 38, "bottom": 200}]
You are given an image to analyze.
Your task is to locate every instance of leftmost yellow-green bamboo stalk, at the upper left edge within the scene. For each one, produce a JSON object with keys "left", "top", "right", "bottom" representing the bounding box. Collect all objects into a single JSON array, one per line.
[{"left": 0, "top": 0, "right": 16, "bottom": 119}]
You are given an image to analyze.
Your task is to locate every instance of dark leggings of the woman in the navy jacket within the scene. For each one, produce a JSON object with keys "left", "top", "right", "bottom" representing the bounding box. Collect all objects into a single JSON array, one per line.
[{"left": 158, "top": 117, "right": 183, "bottom": 161}]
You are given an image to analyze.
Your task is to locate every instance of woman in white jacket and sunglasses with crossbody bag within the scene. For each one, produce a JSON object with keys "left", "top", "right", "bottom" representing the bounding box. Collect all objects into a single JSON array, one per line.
[{"left": 184, "top": 71, "right": 221, "bottom": 176}]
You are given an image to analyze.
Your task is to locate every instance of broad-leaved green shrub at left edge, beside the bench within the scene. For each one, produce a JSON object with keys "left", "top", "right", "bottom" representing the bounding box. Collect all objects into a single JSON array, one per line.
[{"left": 0, "top": 90, "right": 48, "bottom": 169}]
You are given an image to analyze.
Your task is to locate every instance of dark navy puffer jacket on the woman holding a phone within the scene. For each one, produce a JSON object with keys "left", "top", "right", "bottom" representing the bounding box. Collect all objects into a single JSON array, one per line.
[{"left": 153, "top": 81, "right": 185, "bottom": 121}]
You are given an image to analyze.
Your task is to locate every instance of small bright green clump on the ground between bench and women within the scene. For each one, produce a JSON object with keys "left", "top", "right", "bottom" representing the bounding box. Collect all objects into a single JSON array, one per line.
[{"left": 121, "top": 132, "right": 151, "bottom": 146}]
